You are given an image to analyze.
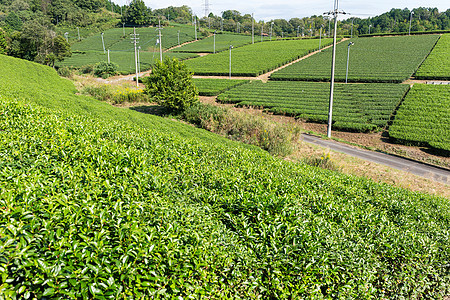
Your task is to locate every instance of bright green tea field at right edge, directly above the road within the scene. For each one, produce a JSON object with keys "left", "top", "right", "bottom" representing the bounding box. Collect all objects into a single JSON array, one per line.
[{"left": 389, "top": 84, "right": 450, "bottom": 151}]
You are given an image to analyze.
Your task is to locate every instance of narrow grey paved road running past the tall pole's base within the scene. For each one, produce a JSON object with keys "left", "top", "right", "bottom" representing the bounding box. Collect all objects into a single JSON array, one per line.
[{"left": 302, "top": 134, "right": 450, "bottom": 184}]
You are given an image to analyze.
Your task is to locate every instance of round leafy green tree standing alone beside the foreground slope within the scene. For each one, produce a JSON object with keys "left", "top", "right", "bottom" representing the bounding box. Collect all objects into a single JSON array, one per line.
[{"left": 143, "top": 58, "right": 198, "bottom": 111}]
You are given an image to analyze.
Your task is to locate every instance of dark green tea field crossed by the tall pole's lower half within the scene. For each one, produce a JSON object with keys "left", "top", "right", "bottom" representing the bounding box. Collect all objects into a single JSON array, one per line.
[{"left": 218, "top": 81, "right": 409, "bottom": 132}]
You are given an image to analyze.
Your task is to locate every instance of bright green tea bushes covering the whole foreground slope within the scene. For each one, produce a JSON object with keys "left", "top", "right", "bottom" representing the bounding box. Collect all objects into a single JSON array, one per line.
[{"left": 0, "top": 56, "right": 450, "bottom": 299}]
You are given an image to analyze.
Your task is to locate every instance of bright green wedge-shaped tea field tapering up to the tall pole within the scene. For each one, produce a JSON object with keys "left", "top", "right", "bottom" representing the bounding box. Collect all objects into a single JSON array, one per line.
[{"left": 186, "top": 39, "right": 332, "bottom": 77}]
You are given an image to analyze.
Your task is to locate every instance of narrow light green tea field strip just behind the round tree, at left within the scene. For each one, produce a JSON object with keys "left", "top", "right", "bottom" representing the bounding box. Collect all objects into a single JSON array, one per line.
[{"left": 56, "top": 49, "right": 197, "bottom": 74}]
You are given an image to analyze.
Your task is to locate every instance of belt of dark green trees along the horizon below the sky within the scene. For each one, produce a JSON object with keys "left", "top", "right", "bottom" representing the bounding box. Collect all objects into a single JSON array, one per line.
[{"left": 0, "top": 0, "right": 450, "bottom": 65}]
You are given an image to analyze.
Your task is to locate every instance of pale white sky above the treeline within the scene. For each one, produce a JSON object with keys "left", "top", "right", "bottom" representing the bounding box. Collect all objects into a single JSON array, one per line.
[{"left": 113, "top": 0, "right": 450, "bottom": 21}]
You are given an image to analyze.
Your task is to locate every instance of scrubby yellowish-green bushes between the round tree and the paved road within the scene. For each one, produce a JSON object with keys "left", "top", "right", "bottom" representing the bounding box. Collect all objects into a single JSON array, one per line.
[{"left": 183, "top": 103, "right": 300, "bottom": 156}]
